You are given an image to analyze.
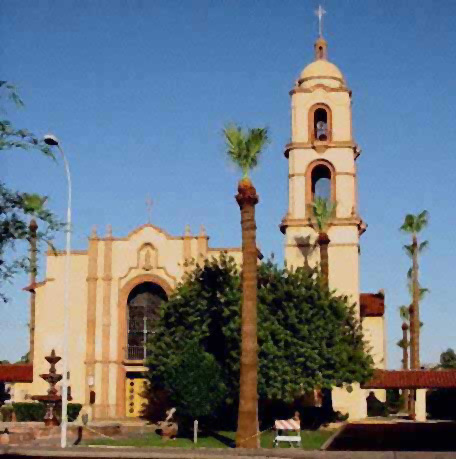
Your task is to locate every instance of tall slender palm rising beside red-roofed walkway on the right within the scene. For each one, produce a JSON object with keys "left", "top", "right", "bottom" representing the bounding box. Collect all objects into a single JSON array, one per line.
[{"left": 400, "top": 210, "right": 429, "bottom": 419}]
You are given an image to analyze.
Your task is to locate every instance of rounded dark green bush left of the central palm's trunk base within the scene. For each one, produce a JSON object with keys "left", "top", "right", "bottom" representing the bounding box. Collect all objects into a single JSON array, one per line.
[{"left": 163, "top": 341, "right": 226, "bottom": 428}]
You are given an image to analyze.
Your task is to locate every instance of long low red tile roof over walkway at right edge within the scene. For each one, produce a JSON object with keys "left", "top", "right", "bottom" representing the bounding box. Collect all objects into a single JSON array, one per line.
[{"left": 362, "top": 370, "right": 456, "bottom": 389}]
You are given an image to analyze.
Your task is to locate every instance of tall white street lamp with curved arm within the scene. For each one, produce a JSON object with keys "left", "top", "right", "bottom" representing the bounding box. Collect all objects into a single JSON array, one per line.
[{"left": 44, "top": 134, "right": 71, "bottom": 448}]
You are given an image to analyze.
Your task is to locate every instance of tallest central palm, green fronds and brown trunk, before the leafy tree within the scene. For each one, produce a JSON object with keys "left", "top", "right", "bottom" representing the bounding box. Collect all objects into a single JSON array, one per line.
[{"left": 223, "top": 125, "right": 269, "bottom": 448}]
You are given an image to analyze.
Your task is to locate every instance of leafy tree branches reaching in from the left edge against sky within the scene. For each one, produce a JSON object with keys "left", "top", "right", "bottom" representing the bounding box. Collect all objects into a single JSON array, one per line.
[{"left": 0, "top": 81, "right": 62, "bottom": 301}]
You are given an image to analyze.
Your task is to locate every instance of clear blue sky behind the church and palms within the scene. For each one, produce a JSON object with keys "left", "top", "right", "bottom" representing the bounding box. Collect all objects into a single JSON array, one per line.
[{"left": 0, "top": 0, "right": 456, "bottom": 368}]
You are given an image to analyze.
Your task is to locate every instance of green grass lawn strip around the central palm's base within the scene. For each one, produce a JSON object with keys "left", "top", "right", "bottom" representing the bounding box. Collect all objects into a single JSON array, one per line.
[{"left": 84, "top": 430, "right": 334, "bottom": 450}]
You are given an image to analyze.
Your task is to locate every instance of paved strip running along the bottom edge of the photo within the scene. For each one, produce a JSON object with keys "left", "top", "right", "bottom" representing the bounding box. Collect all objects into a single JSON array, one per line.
[{"left": 0, "top": 446, "right": 456, "bottom": 459}]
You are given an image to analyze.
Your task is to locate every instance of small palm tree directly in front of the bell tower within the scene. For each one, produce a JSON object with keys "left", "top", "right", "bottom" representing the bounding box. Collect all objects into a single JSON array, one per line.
[{"left": 312, "top": 197, "right": 336, "bottom": 288}]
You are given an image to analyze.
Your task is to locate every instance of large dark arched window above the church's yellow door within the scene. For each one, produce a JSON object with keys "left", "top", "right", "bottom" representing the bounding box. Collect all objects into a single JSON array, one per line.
[{"left": 127, "top": 282, "right": 167, "bottom": 360}]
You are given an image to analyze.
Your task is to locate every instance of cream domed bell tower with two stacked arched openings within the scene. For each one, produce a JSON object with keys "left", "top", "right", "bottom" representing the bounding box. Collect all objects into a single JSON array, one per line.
[{"left": 281, "top": 36, "right": 365, "bottom": 304}]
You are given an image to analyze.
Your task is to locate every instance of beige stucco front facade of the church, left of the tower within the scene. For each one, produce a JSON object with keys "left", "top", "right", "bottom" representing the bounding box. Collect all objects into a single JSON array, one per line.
[{"left": 14, "top": 224, "right": 242, "bottom": 419}]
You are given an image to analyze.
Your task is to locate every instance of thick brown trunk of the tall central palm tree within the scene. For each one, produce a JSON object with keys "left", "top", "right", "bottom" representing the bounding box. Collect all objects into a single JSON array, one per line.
[{"left": 236, "top": 179, "right": 260, "bottom": 448}]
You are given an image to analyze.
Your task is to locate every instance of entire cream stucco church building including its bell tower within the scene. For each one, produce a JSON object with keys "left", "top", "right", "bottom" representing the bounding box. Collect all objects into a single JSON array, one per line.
[{"left": 8, "top": 31, "right": 386, "bottom": 419}]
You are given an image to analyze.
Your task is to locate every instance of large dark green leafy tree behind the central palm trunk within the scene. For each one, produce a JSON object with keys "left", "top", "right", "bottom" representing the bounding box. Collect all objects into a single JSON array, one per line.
[{"left": 147, "top": 255, "right": 373, "bottom": 424}]
